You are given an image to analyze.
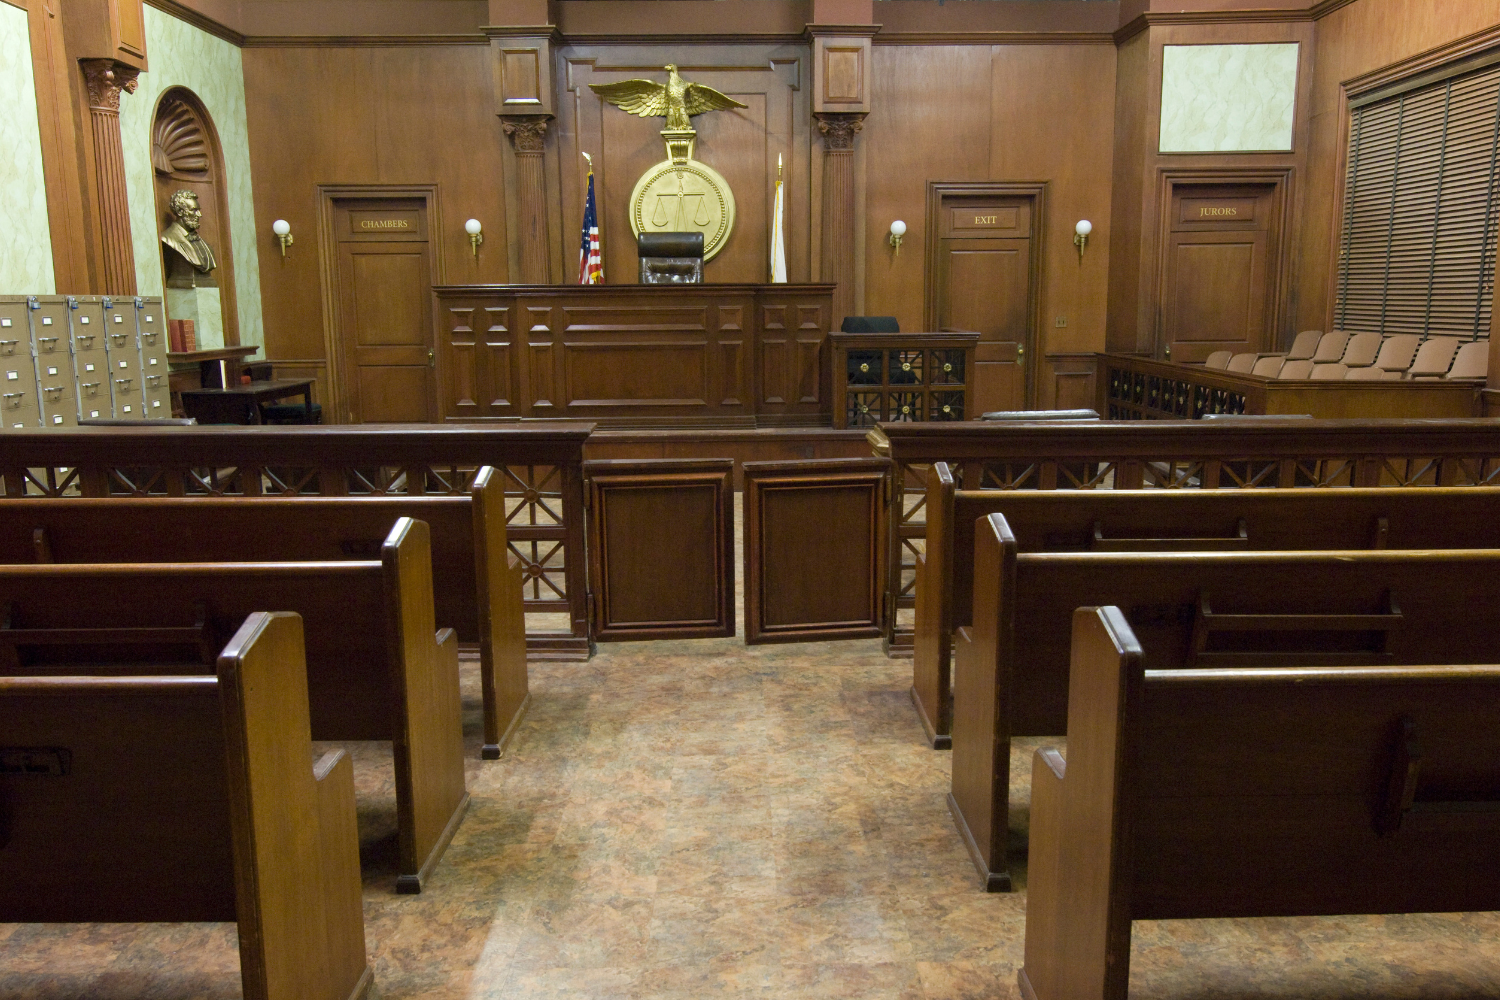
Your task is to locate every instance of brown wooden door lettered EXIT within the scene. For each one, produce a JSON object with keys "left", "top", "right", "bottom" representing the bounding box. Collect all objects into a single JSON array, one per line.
[{"left": 936, "top": 196, "right": 1034, "bottom": 414}]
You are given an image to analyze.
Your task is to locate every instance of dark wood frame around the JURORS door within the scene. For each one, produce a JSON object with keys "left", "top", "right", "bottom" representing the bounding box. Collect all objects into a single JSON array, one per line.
[{"left": 1152, "top": 167, "right": 1296, "bottom": 359}]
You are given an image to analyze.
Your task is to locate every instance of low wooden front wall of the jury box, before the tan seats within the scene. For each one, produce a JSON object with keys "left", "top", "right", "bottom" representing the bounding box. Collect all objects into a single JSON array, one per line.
[{"left": 1095, "top": 354, "right": 1484, "bottom": 420}]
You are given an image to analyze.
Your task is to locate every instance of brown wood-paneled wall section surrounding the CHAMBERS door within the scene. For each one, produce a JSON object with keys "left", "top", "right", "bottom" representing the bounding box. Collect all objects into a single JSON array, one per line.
[{"left": 245, "top": 43, "right": 509, "bottom": 370}]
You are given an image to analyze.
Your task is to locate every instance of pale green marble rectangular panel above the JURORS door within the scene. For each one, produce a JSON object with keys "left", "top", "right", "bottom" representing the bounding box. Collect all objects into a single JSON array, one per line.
[{"left": 1160, "top": 42, "right": 1298, "bottom": 153}]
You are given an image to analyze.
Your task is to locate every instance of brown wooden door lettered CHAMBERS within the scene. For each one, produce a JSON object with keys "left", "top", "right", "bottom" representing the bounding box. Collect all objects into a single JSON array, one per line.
[{"left": 335, "top": 199, "right": 438, "bottom": 423}]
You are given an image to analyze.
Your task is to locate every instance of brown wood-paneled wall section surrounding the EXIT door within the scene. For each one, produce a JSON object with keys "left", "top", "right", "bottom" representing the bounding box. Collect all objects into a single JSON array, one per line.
[{"left": 861, "top": 36, "right": 1115, "bottom": 406}]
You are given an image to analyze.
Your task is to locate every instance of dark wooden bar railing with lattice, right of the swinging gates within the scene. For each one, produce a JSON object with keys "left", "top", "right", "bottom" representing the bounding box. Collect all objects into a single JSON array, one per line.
[{"left": 869, "top": 418, "right": 1500, "bottom": 652}]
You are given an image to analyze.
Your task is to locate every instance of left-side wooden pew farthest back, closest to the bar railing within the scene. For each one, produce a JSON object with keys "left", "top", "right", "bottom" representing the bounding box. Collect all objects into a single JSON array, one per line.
[{"left": 0, "top": 466, "right": 531, "bottom": 760}]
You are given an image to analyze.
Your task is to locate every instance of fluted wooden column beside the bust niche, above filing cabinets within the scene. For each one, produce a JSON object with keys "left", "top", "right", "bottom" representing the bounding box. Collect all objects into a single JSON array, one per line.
[{"left": 80, "top": 58, "right": 141, "bottom": 295}]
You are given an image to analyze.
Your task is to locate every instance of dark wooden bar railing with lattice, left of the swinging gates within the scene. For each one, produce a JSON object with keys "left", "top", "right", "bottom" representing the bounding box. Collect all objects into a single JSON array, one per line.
[{"left": 0, "top": 421, "right": 594, "bottom": 660}]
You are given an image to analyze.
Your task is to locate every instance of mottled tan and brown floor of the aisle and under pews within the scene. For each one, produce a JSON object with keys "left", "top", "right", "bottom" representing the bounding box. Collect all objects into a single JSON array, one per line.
[{"left": 0, "top": 497, "right": 1500, "bottom": 1000}]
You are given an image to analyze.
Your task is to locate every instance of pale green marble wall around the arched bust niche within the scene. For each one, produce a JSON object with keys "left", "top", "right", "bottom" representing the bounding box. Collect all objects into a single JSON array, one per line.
[{"left": 120, "top": 6, "right": 266, "bottom": 348}]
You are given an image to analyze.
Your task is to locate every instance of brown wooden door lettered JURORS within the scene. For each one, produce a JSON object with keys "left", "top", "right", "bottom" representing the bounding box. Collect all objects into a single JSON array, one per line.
[{"left": 1160, "top": 184, "right": 1277, "bottom": 363}]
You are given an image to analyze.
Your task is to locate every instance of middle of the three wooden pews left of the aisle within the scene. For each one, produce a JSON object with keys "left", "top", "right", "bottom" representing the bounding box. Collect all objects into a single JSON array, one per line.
[{"left": 0, "top": 517, "right": 470, "bottom": 892}]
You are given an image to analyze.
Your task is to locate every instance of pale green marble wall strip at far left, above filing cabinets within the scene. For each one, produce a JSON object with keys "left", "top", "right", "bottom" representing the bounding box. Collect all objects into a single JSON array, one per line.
[{"left": 0, "top": 3, "right": 57, "bottom": 295}]
